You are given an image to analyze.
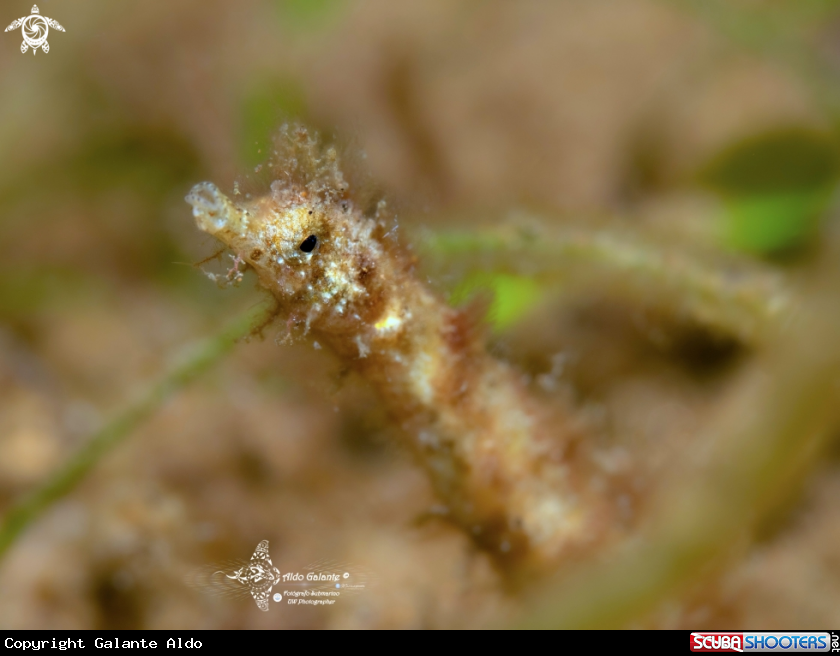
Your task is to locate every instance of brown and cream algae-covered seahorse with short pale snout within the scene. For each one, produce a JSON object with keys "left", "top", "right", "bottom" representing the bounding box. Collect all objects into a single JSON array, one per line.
[{"left": 187, "top": 125, "right": 611, "bottom": 567}]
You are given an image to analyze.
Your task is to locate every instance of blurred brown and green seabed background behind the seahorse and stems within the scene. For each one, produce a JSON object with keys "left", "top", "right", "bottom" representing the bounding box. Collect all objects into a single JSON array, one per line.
[{"left": 0, "top": 0, "right": 840, "bottom": 629}]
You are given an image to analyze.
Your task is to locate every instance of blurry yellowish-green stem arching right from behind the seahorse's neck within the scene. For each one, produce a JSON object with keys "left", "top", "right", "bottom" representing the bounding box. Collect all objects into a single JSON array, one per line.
[{"left": 419, "top": 222, "right": 793, "bottom": 344}]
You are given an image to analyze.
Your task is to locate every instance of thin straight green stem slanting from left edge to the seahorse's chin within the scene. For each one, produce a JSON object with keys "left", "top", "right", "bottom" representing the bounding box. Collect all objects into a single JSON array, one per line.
[{"left": 0, "top": 305, "right": 275, "bottom": 558}]
